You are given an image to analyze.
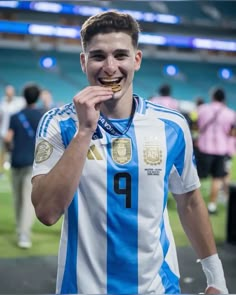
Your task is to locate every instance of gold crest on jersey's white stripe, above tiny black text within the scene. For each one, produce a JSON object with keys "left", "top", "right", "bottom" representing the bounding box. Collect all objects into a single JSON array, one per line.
[{"left": 143, "top": 138, "right": 163, "bottom": 165}]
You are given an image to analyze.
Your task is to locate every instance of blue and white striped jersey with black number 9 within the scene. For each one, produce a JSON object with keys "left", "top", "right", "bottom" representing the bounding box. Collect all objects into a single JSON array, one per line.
[{"left": 33, "top": 96, "right": 200, "bottom": 294}]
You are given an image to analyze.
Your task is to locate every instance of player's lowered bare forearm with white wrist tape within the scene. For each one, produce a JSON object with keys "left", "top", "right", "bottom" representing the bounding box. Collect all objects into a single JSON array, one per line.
[{"left": 175, "top": 190, "right": 228, "bottom": 294}]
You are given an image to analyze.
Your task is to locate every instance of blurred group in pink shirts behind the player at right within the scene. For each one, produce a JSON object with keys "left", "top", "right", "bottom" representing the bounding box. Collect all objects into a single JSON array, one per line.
[{"left": 150, "top": 84, "right": 236, "bottom": 214}]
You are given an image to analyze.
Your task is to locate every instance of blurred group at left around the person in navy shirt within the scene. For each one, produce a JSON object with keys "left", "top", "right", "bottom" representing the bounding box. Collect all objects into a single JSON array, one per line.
[{"left": 0, "top": 83, "right": 54, "bottom": 249}]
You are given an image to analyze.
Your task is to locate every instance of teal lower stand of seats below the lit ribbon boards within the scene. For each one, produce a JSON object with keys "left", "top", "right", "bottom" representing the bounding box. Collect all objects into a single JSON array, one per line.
[{"left": 0, "top": 48, "right": 236, "bottom": 107}]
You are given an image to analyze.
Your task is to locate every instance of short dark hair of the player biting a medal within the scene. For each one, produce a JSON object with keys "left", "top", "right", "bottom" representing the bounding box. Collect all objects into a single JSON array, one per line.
[{"left": 80, "top": 10, "right": 140, "bottom": 50}]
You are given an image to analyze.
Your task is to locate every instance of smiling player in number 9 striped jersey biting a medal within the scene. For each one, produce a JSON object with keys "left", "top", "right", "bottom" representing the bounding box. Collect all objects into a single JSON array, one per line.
[{"left": 32, "top": 11, "right": 227, "bottom": 294}]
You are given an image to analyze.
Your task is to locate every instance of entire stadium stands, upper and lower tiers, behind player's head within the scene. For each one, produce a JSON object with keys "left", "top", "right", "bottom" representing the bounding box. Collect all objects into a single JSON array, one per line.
[{"left": 0, "top": 1, "right": 236, "bottom": 107}]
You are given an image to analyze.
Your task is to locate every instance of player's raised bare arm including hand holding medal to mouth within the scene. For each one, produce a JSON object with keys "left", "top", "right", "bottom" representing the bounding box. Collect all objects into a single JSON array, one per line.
[{"left": 32, "top": 86, "right": 113, "bottom": 225}]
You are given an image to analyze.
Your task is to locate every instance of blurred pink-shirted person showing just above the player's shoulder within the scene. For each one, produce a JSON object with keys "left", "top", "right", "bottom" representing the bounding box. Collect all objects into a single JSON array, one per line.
[{"left": 150, "top": 84, "right": 179, "bottom": 110}]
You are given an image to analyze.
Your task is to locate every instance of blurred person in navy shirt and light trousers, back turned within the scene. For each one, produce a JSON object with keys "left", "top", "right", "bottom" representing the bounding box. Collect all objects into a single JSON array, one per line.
[{"left": 4, "top": 83, "right": 42, "bottom": 249}]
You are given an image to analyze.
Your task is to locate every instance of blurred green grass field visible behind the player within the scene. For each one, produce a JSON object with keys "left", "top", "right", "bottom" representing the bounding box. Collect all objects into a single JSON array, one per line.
[{"left": 0, "top": 165, "right": 232, "bottom": 258}]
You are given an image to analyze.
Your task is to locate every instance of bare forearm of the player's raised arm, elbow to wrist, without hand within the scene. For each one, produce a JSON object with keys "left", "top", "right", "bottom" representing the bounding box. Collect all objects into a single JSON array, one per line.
[{"left": 32, "top": 133, "right": 91, "bottom": 225}]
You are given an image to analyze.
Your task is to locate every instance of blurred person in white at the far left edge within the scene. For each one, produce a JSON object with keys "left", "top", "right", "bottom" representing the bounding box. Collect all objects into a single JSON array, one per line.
[{"left": 0, "top": 85, "right": 25, "bottom": 172}]
